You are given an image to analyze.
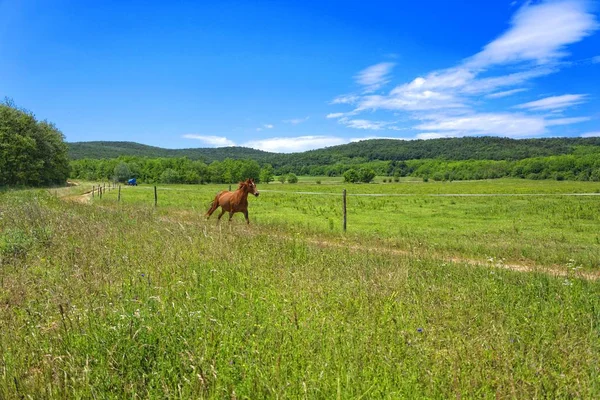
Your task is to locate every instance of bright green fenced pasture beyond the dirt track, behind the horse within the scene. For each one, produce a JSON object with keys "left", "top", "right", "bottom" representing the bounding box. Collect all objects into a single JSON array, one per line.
[{"left": 94, "top": 180, "right": 600, "bottom": 271}]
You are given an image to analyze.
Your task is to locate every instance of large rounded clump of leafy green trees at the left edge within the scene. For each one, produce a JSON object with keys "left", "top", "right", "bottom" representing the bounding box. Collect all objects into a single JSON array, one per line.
[{"left": 0, "top": 99, "right": 69, "bottom": 186}]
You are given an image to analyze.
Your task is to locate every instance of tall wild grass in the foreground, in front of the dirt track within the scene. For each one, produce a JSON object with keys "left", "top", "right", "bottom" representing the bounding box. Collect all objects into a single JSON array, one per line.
[{"left": 0, "top": 187, "right": 600, "bottom": 399}]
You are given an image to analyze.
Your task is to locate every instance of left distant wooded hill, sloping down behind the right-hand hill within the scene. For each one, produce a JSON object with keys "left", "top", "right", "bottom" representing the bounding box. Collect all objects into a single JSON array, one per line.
[{"left": 69, "top": 142, "right": 275, "bottom": 163}]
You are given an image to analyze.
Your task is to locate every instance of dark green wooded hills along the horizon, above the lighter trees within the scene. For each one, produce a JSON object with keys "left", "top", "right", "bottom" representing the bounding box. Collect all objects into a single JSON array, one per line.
[{"left": 69, "top": 137, "right": 600, "bottom": 165}]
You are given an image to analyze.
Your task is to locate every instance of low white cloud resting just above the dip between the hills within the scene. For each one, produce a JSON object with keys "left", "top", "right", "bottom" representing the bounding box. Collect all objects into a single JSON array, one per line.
[{"left": 244, "top": 136, "right": 348, "bottom": 153}]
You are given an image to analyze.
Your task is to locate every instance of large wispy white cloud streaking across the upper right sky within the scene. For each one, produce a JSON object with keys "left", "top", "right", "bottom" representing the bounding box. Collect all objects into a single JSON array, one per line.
[{"left": 328, "top": 0, "right": 599, "bottom": 137}]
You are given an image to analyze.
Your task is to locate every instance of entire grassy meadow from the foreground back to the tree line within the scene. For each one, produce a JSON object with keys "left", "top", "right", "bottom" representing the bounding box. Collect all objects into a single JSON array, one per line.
[{"left": 0, "top": 180, "right": 600, "bottom": 399}]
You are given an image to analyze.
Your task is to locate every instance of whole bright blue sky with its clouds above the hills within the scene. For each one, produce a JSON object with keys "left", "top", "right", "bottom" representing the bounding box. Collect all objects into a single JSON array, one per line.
[{"left": 0, "top": 0, "right": 600, "bottom": 152}]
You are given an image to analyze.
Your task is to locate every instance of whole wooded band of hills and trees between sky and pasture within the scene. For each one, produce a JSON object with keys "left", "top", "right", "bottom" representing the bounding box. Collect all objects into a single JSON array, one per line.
[{"left": 70, "top": 137, "right": 600, "bottom": 183}]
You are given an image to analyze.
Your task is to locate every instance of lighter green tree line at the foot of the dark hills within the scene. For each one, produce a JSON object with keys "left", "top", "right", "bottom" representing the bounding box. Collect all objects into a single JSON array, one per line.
[{"left": 71, "top": 152, "right": 600, "bottom": 184}]
